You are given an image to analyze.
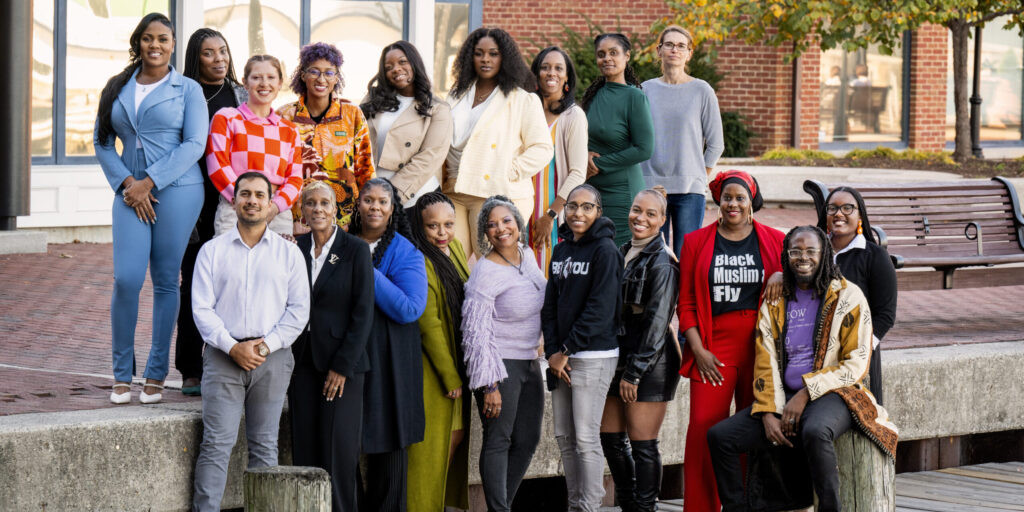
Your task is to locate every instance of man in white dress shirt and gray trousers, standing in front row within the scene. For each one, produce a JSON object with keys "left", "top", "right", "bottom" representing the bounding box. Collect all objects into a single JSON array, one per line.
[{"left": 193, "top": 172, "right": 309, "bottom": 512}]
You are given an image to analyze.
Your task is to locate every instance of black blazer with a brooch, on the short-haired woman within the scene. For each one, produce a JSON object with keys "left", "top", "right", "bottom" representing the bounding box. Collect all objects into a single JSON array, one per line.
[{"left": 292, "top": 228, "right": 374, "bottom": 377}]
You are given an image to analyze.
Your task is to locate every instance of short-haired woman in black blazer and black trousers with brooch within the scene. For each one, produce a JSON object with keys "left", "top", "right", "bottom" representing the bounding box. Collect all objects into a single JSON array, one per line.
[{"left": 288, "top": 181, "right": 374, "bottom": 511}]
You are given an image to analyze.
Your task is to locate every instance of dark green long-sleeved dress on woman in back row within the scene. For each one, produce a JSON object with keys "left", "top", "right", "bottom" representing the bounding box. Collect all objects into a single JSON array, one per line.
[{"left": 587, "top": 82, "right": 654, "bottom": 246}]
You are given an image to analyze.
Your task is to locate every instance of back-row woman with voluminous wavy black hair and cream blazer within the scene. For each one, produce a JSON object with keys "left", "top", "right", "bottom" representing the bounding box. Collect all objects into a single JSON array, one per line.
[{"left": 442, "top": 28, "right": 554, "bottom": 256}]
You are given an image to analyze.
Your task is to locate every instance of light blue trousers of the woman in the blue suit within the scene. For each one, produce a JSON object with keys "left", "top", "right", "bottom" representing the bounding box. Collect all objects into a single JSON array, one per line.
[{"left": 111, "top": 171, "right": 203, "bottom": 382}]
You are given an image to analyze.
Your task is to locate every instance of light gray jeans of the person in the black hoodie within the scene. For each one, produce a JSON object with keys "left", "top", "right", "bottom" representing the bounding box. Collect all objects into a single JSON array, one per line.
[{"left": 548, "top": 357, "right": 618, "bottom": 512}]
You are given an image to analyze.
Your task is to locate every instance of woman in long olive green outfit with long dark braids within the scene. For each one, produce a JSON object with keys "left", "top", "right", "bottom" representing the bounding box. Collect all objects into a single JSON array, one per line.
[{"left": 407, "top": 191, "right": 469, "bottom": 512}]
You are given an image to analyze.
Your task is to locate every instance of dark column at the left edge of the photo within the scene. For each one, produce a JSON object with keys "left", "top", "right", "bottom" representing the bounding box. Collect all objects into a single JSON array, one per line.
[{"left": 0, "top": 1, "right": 33, "bottom": 231}]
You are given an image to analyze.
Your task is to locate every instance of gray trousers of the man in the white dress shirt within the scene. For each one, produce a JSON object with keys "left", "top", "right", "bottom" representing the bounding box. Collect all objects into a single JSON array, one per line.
[{"left": 193, "top": 346, "right": 295, "bottom": 512}]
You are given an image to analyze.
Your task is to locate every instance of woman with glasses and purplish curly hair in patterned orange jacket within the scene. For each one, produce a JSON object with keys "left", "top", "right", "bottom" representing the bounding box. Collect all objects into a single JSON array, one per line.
[{"left": 278, "top": 43, "right": 375, "bottom": 234}]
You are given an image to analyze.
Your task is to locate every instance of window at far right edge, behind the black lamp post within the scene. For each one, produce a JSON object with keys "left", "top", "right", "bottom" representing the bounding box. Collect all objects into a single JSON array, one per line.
[{"left": 946, "top": 16, "right": 1024, "bottom": 142}]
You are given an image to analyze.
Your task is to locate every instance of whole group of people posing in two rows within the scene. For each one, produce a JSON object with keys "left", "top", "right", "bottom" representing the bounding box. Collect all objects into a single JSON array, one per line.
[{"left": 94, "top": 13, "right": 896, "bottom": 511}]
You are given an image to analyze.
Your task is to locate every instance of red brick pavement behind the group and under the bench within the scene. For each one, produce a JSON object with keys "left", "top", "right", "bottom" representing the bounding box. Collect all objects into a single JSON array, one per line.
[{"left": 0, "top": 204, "right": 1024, "bottom": 416}]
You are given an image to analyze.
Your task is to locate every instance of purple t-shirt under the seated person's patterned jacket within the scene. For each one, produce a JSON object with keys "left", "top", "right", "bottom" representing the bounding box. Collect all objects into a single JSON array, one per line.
[{"left": 782, "top": 288, "right": 821, "bottom": 391}]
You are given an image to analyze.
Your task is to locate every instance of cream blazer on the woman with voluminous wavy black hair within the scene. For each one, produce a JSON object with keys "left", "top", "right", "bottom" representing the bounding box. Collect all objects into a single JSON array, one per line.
[{"left": 444, "top": 87, "right": 554, "bottom": 200}]
